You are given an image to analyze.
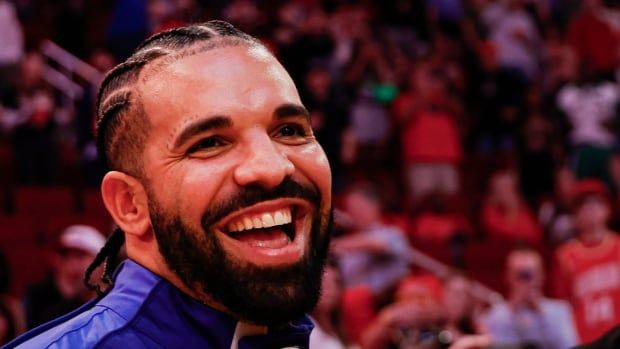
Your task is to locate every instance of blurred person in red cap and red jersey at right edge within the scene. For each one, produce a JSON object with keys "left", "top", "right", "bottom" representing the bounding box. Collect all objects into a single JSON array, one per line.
[{"left": 552, "top": 179, "right": 620, "bottom": 342}]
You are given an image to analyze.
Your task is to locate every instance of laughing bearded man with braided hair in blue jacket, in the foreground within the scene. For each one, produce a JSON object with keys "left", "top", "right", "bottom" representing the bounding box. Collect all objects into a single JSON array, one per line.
[{"left": 9, "top": 21, "right": 331, "bottom": 348}]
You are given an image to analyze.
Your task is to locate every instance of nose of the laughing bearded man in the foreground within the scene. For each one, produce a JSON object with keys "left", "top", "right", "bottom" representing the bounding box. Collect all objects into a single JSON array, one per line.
[{"left": 234, "top": 134, "right": 295, "bottom": 188}]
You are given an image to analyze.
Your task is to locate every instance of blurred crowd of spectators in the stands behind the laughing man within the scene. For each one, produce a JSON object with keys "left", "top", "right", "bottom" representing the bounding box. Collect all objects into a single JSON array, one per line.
[{"left": 0, "top": 0, "right": 620, "bottom": 348}]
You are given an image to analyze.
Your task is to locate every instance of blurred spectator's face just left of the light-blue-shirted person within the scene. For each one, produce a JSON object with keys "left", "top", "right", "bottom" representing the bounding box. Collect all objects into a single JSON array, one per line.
[{"left": 443, "top": 276, "right": 472, "bottom": 322}]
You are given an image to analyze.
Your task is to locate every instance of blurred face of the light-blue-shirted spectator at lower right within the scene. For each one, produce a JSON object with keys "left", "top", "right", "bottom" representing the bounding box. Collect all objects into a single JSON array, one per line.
[{"left": 506, "top": 251, "right": 544, "bottom": 298}]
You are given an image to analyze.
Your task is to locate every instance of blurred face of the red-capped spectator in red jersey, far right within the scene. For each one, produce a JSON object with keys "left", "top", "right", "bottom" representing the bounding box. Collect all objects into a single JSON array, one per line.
[{"left": 575, "top": 195, "right": 609, "bottom": 242}]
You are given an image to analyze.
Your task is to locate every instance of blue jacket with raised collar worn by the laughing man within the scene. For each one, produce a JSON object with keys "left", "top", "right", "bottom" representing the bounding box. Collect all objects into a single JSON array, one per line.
[{"left": 2, "top": 260, "right": 313, "bottom": 349}]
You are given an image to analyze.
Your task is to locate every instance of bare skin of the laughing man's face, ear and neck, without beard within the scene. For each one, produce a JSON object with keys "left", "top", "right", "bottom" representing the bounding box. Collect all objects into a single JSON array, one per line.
[{"left": 101, "top": 45, "right": 331, "bottom": 312}]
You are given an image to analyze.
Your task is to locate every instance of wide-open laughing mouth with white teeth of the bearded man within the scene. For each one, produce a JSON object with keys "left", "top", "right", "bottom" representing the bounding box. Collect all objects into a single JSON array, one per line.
[{"left": 215, "top": 199, "right": 312, "bottom": 264}]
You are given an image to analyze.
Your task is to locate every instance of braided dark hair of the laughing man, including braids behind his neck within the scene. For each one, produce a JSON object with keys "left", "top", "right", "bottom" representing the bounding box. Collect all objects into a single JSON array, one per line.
[{"left": 84, "top": 20, "right": 264, "bottom": 294}]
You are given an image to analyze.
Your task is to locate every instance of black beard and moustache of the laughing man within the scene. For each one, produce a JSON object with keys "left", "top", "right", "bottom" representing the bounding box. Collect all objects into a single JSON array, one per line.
[{"left": 147, "top": 178, "right": 331, "bottom": 326}]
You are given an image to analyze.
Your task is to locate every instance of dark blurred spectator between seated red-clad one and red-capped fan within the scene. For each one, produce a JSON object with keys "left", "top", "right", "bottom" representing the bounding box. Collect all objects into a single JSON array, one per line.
[{"left": 538, "top": 167, "right": 576, "bottom": 246}]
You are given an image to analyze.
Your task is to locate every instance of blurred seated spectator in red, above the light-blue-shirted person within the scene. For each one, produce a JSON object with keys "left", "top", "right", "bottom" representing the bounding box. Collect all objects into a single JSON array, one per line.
[{"left": 481, "top": 170, "right": 542, "bottom": 245}]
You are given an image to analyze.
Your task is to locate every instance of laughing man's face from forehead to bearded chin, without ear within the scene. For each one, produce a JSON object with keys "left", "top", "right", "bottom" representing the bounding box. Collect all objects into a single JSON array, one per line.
[{"left": 134, "top": 42, "right": 331, "bottom": 324}]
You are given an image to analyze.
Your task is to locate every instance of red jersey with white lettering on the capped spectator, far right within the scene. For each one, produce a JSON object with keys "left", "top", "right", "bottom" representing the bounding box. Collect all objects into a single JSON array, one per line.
[{"left": 552, "top": 235, "right": 620, "bottom": 343}]
